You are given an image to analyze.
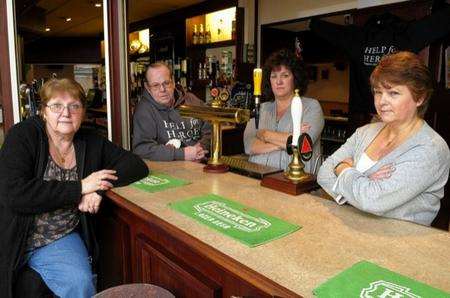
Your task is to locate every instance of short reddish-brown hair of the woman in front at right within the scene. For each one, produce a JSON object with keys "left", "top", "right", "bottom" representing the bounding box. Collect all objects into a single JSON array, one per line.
[{"left": 370, "top": 51, "right": 433, "bottom": 117}]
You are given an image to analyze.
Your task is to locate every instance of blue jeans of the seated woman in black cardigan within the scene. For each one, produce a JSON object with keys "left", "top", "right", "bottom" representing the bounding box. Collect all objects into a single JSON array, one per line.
[{"left": 26, "top": 232, "right": 95, "bottom": 298}]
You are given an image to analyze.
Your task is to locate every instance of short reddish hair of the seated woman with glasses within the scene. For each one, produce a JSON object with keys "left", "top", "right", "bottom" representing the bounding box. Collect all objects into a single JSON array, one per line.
[{"left": 39, "top": 79, "right": 86, "bottom": 114}]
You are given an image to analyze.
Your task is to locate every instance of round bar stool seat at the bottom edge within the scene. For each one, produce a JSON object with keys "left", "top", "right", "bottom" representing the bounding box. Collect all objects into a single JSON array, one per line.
[{"left": 94, "top": 284, "right": 175, "bottom": 298}]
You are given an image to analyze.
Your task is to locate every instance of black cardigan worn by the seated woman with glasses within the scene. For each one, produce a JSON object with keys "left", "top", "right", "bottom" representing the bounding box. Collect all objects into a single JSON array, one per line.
[{"left": 0, "top": 117, "right": 149, "bottom": 297}]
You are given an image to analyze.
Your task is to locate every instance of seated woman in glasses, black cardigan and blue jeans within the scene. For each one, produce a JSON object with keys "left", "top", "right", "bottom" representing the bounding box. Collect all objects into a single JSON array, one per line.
[{"left": 0, "top": 79, "right": 148, "bottom": 297}]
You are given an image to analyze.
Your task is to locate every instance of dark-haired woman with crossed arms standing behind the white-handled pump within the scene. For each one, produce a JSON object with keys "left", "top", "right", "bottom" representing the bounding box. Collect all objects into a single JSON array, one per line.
[{"left": 244, "top": 50, "right": 324, "bottom": 173}]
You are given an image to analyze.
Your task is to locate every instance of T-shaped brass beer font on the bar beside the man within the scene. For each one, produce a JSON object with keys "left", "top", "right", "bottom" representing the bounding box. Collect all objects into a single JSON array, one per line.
[{"left": 179, "top": 90, "right": 250, "bottom": 173}]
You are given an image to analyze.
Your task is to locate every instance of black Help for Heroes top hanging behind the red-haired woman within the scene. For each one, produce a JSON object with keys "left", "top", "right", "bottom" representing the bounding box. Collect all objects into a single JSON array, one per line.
[{"left": 311, "top": 5, "right": 450, "bottom": 114}]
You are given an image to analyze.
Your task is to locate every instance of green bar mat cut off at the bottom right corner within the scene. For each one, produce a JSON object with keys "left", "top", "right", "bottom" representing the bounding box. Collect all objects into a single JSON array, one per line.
[{"left": 313, "top": 261, "right": 450, "bottom": 298}]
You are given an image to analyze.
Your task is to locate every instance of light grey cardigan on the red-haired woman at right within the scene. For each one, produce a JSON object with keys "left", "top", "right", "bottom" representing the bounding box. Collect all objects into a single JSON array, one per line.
[{"left": 317, "top": 122, "right": 450, "bottom": 225}]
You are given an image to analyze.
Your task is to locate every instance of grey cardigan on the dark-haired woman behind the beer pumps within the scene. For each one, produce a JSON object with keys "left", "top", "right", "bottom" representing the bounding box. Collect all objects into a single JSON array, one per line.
[{"left": 244, "top": 97, "right": 324, "bottom": 173}]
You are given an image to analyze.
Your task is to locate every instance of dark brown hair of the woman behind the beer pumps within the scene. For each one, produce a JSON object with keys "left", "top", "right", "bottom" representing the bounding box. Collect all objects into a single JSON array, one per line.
[{"left": 263, "top": 49, "right": 308, "bottom": 100}]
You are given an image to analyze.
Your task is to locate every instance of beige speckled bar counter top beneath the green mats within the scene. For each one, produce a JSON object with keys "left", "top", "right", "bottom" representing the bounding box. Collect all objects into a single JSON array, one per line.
[{"left": 113, "top": 161, "right": 450, "bottom": 297}]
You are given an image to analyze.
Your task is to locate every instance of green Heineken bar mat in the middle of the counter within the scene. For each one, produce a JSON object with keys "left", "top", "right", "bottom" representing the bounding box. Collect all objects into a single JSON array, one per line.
[{"left": 169, "top": 194, "right": 300, "bottom": 247}]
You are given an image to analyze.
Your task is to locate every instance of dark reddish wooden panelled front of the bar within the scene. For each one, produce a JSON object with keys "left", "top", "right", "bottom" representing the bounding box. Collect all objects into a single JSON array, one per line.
[{"left": 97, "top": 193, "right": 299, "bottom": 297}]
